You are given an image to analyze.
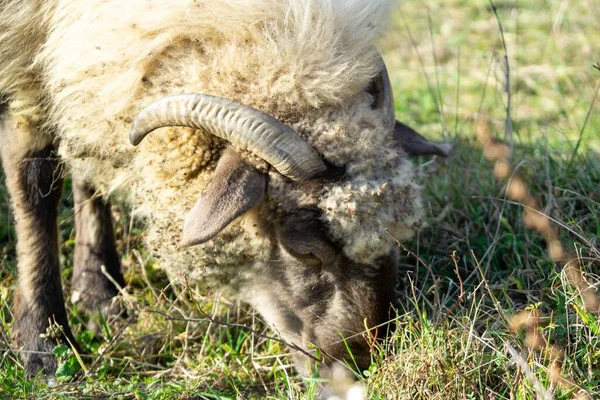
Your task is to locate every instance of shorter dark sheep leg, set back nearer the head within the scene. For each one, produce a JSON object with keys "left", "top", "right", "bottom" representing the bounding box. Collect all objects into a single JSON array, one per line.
[{"left": 71, "top": 177, "right": 125, "bottom": 324}]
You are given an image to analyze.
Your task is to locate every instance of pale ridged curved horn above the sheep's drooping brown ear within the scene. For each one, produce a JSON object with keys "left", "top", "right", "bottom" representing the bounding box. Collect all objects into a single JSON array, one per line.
[{"left": 129, "top": 94, "right": 327, "bottom": 181}]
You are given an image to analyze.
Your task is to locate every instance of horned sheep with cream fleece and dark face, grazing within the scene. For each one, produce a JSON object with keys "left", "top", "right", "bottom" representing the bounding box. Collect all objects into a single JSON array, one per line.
[{"left": 0, "top": 0, "right": 449, "bottom": 376}]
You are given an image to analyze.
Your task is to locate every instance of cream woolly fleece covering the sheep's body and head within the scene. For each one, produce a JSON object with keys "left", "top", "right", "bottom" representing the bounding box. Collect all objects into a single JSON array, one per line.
[{"left": 0, "top": 0, "right": 422, "bottom": 284}]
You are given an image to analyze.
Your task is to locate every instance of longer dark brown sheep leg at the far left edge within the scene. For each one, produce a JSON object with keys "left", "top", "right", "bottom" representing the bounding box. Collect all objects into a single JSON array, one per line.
[{"left": 0, "top": 111, "right": 76, "bottom": 377}]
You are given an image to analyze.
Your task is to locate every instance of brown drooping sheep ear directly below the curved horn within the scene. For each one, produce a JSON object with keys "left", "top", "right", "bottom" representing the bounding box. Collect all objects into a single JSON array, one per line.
[{"left": 181, "top": 150, "right": 267, "bottom": 247}]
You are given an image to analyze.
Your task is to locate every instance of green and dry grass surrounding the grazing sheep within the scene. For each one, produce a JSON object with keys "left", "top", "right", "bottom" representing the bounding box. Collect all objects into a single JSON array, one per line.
[{"left": 0, "top": 0, "right": 600, "bottom": 399}]
